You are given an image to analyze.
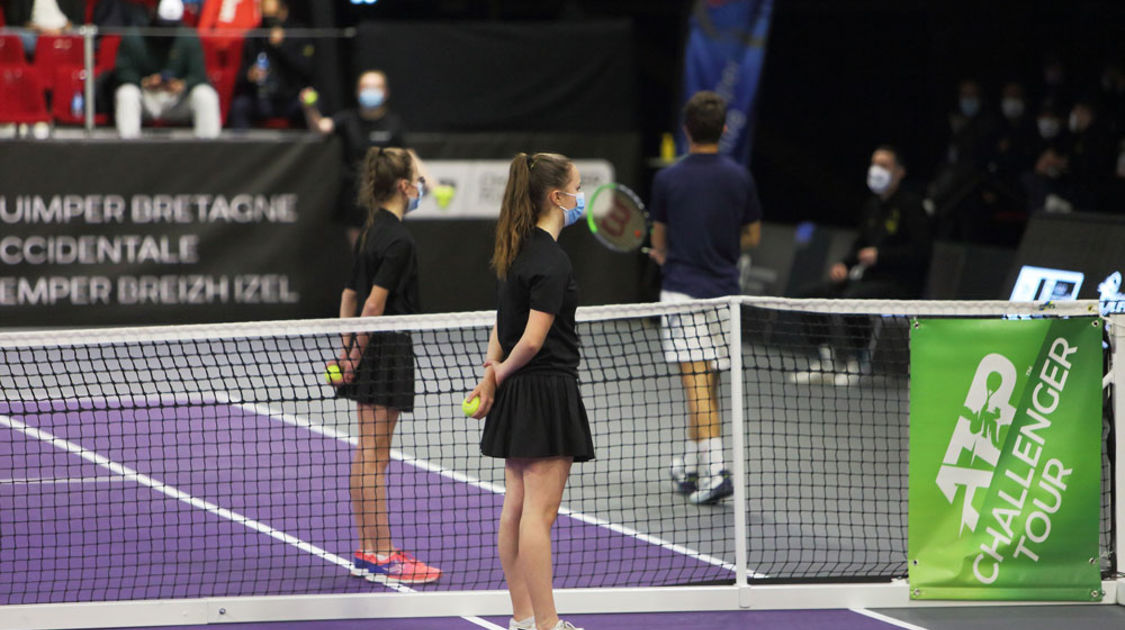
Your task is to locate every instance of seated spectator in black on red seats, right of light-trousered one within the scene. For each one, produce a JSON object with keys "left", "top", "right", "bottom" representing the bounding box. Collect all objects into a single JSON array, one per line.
[{"left": 231, "top": 0, "right": 315, "bottom": 129}]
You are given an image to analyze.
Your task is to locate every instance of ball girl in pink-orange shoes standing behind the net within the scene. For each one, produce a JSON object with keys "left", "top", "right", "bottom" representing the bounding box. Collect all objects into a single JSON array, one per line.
[{"left": 336, "top": 147, "right": 441, "bottom": 584}]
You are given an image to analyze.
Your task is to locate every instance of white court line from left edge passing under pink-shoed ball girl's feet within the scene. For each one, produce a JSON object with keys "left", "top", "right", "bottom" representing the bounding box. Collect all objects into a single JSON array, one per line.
[{"left": 0, "top": 415, "right": 504, "bottom": 630}]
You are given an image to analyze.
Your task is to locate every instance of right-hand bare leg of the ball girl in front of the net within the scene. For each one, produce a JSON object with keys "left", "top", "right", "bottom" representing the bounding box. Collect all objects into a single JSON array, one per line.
[{"left": 518, "top": 457, "right": 574, "bottom": 630}]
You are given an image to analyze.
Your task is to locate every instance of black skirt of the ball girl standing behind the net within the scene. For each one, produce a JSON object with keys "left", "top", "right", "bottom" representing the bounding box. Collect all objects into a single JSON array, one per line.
[{"left": 336, "top": 333, "right": 414, "bottom": 412}]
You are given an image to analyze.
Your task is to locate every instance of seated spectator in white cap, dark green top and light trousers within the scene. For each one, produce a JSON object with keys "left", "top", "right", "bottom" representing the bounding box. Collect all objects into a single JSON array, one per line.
[{"left": 114, "top": 0, "right": 222, "bottom": 138}]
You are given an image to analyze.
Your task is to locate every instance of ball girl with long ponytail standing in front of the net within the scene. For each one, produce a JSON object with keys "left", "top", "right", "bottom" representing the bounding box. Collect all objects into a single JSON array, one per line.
[{"left": 469, "top": 153, "right": 594, "bottom": 630}]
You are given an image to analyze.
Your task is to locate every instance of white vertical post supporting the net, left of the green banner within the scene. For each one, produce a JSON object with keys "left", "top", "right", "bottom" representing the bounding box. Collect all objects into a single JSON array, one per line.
[{"left": 728, "top": 296, "right": 749, "bottom": 608}]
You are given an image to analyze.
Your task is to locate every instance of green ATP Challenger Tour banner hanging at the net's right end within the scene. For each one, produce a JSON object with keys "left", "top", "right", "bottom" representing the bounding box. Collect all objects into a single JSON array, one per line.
[{"left": 908, "top": 317, "right": 1104, "bottom": 601}]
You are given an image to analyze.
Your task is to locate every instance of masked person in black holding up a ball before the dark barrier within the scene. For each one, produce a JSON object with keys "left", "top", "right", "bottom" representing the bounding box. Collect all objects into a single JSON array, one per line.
[{"left": 300, "top": 70, "right": 411, "bottom": 245}]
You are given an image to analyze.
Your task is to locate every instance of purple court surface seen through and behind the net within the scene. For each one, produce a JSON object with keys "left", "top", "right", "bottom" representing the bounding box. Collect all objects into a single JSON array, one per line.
[{"left": 0, "top": 398, "right": 734, "bottom": 604}]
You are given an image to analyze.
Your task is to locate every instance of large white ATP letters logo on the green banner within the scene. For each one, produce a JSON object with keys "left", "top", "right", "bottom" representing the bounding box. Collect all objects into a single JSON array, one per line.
[{"left": 936, "top": 353, "right": 1016, "bottom": 533}]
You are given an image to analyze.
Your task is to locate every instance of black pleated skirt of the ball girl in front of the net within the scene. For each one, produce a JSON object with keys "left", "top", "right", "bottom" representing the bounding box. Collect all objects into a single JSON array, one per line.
[{"left": 480, "top": 372, "right": 594, "bottom": 461}]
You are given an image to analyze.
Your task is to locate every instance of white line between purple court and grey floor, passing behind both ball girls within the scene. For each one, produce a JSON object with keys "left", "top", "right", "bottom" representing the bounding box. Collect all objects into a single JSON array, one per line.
[{"left": 215, "top": 393, "right": 768, "bottom": 578}]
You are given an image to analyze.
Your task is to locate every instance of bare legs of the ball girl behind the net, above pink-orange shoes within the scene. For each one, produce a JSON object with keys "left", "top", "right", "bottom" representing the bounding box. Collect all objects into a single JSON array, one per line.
[{"left": 351, "top": 403, "right": 399, "bottom": 554}]
